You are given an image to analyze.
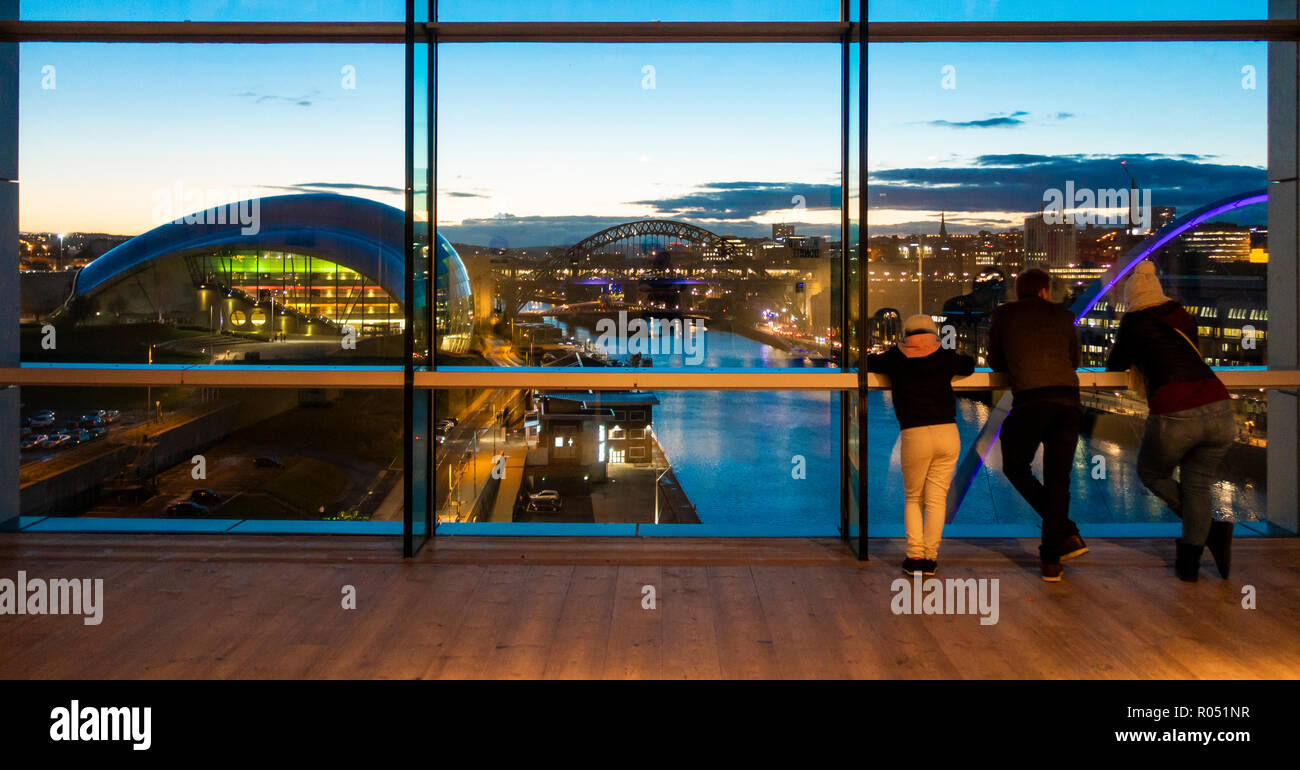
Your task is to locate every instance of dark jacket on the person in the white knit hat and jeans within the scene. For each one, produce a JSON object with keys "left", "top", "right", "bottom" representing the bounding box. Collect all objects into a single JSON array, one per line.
[{"left": 1106, "top": 300, "right": 1229, "bottom": 415}]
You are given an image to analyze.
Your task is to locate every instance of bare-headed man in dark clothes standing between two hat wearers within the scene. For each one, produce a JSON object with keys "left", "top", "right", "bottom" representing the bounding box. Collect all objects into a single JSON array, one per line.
[{"left": 988, "top": 269, "right": 1088, "bottom": 583}]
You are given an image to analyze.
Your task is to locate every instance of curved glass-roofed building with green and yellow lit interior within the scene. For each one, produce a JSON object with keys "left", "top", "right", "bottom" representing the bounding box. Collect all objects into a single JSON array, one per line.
[{"left": 64, "top": 194, "right": 473, "bottom": 354}]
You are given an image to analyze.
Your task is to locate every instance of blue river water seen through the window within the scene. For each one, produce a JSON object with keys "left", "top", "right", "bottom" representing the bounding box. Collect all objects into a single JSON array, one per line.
[{"left": 543, "top": 316, "right": 1265, "bottom": 536}]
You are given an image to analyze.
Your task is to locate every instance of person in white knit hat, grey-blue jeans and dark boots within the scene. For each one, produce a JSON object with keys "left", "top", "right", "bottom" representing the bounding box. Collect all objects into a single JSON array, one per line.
[{"left": 1106, "top": 261, "right": 1236, "bottom": 581}]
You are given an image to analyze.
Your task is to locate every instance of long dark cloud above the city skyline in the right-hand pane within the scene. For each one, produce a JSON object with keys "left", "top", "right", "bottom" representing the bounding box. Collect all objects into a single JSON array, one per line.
[{"left": 868, "top": 153, "right": 1266, "bottom": 212}]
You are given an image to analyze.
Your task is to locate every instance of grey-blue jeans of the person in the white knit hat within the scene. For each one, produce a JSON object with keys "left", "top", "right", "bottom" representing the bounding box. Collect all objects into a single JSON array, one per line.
[{"left": 1138, "top": 401, "right": 1236, "bottom": 545}]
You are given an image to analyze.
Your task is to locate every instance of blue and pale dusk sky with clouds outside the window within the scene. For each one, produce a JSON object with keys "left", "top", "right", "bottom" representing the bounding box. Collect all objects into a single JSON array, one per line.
[{"left": 10, "top": 0, "right": 1268, "bottom": 246}]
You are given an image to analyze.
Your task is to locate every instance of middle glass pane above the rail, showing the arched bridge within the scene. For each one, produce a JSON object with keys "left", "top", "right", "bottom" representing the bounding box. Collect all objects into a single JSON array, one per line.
[{"left": 438, "top": 44, "right": 841, "bottom": 369}]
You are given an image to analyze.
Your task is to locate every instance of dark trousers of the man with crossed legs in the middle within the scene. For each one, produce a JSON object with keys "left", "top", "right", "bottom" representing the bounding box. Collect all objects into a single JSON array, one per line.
[{"left": 1001, "top": 401, "right": 1083, "bottom": 564}]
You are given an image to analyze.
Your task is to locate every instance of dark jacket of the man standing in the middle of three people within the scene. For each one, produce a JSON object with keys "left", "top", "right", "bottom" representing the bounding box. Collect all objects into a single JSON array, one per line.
[{"left": 988, "top": 297, "right": 1080, "bottom": 403}]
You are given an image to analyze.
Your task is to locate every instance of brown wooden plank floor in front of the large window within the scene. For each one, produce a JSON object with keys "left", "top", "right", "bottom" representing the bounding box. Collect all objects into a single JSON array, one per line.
[{"left": 0, "top": 535, "right": 1300, "bottom": 679}]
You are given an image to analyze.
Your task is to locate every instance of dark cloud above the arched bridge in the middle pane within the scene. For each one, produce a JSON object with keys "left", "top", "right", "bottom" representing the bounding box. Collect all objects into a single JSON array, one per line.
[{"left": 631, "top": 182, "right": 840, "bottom": 224}]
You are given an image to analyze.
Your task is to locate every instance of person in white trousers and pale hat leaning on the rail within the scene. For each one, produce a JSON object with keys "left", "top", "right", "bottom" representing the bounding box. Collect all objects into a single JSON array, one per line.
[{"left": 867, "top": 315, "right": 975, "bottom": 575}]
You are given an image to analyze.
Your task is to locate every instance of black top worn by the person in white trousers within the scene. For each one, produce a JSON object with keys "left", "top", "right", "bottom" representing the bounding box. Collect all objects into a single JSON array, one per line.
[{"left": 867, "top": 347, "right": 975, "bottom": 429}]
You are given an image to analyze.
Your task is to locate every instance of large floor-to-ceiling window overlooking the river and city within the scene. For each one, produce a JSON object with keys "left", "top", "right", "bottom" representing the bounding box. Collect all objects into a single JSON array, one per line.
[{"left": 0, "top": 0, "right": 1300, "bottom": 557}]
